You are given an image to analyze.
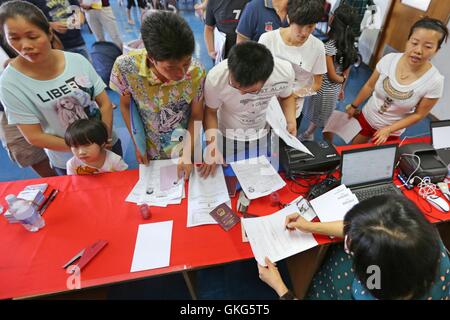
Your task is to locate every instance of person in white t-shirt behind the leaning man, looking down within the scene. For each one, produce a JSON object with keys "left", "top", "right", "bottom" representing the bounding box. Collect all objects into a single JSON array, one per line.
[{"left": 259, "top": 0, "right": 327, "bottom": 126}]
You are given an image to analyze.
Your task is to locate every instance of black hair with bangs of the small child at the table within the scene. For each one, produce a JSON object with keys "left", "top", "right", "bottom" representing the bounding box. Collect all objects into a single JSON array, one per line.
[{"left": 64, "top": 119, "right": 108, "bottom": 147}]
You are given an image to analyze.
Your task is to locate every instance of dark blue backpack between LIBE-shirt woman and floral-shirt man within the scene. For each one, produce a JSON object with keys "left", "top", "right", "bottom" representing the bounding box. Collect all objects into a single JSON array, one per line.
[{"left": 91, "top": 41, "right": 122, "bottom": 87}]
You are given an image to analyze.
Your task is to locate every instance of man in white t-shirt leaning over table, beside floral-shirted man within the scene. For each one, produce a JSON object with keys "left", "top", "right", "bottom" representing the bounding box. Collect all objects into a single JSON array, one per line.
[{"left": 200, "top": 42, "right": 297, "bottom": 176}]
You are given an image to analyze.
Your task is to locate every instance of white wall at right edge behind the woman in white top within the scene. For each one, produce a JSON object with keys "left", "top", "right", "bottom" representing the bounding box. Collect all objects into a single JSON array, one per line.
[{"left": 431, "top": 22, "right": 450, "bottom": 120}]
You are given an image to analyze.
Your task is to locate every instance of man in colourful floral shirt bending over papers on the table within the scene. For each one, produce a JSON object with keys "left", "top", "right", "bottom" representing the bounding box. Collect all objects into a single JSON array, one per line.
[{"left": 110, "top": 11, "right": 206, "bottom": 179}]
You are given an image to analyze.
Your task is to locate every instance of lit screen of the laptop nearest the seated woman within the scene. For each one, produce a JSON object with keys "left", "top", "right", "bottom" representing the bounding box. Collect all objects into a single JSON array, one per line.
[{"left": 341, "top": 144, "right": 397, "bottom": 188}]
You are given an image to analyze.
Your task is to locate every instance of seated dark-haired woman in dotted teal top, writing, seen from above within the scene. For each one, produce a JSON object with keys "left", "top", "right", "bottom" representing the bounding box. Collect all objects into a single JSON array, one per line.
[{"left": 258, "top": 195, "right": 450, "bottom": 300}]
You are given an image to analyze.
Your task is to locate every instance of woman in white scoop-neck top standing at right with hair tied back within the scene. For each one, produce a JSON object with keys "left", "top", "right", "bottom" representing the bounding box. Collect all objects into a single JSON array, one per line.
[{"left": 346, "top": 18, "right": 448, "bottom": 145}]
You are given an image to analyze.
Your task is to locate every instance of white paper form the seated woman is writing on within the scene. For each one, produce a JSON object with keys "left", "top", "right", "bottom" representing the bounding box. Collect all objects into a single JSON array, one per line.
[{"left": 243, "top": 205, "right": 318, "bottom": 266}]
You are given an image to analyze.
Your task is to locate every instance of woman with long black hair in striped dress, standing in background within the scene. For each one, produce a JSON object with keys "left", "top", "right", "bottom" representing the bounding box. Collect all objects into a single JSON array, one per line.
[{"left": 300, "top": 4, "right": 358, "bottom": 142}]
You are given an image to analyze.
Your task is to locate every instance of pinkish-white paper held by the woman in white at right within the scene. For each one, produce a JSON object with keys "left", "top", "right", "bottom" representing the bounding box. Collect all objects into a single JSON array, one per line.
[{"left": 323, "top": 110, "right": 362, "bottom": 143}]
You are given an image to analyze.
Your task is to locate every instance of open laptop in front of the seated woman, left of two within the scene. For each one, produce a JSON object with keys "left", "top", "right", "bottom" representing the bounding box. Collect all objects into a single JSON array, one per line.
[{"left": 341, "top": 144, "right": 402, "bottom": 201}]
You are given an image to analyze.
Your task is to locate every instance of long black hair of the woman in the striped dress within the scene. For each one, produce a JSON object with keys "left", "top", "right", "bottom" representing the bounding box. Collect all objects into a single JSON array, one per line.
[{"left": 328, "top": 4, "right": 358, "bottom": 70}]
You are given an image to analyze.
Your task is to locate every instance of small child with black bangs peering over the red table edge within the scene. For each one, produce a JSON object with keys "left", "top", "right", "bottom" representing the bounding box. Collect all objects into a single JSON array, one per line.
[{"left": 64, "top": 119, "right": 128, "bottom": 175}]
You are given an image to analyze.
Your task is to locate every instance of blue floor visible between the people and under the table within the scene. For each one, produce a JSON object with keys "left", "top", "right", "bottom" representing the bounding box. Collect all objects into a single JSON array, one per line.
[{"left": 0, "top": 0, "right": 429, "bottom": 299}]
